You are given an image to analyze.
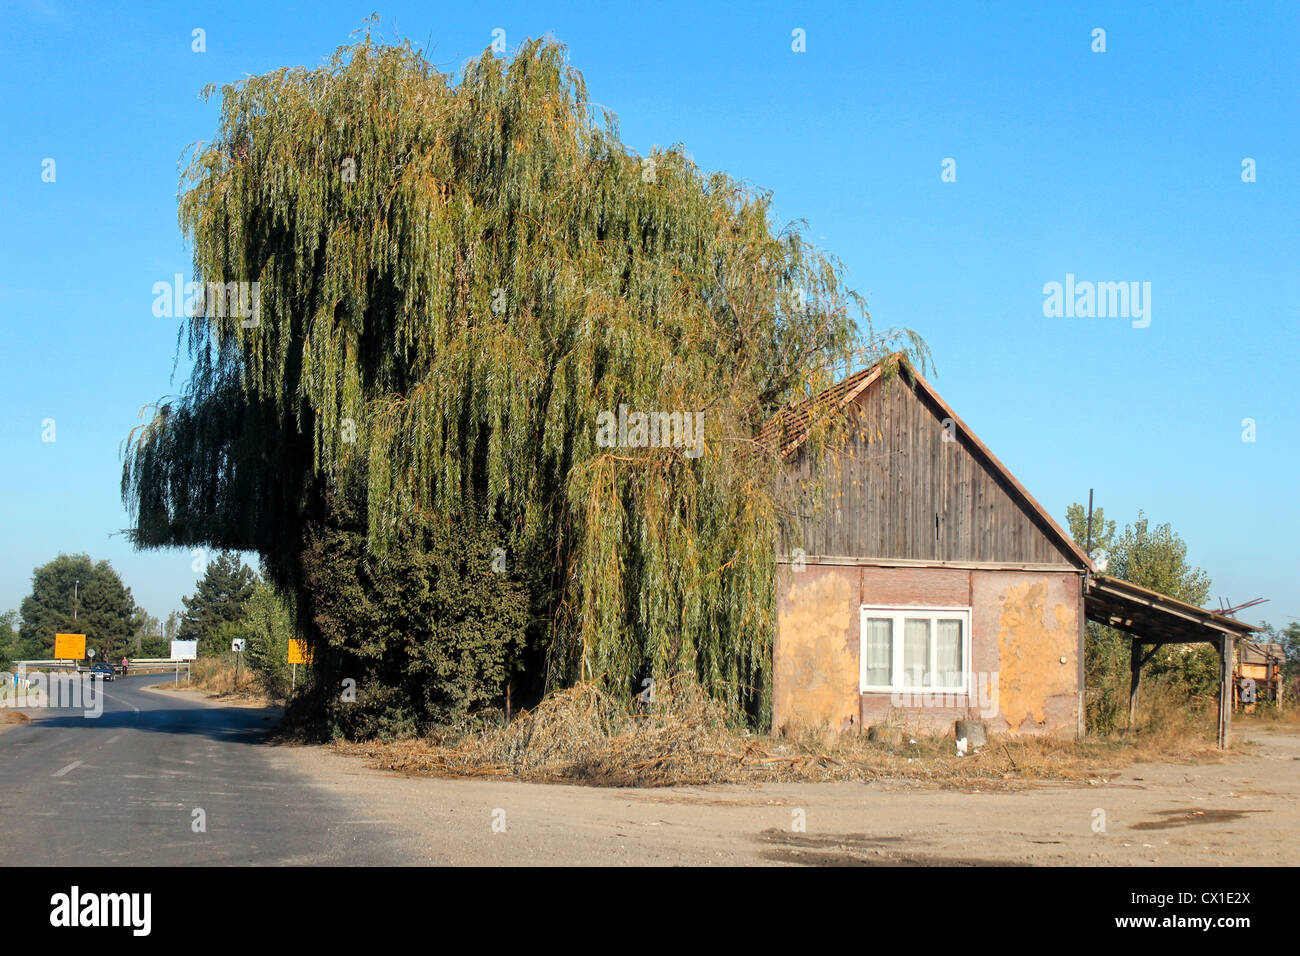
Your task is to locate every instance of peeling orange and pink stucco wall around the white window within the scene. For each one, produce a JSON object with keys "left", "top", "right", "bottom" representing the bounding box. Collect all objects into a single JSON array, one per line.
[{"left": 772, "top": 564, "right": 1082, "bottom": 734}]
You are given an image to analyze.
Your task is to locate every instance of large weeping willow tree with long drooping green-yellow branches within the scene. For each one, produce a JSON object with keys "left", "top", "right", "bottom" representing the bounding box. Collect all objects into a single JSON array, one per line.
[{"left": 122, "top": 26, "right": 920, "bottom": 710}]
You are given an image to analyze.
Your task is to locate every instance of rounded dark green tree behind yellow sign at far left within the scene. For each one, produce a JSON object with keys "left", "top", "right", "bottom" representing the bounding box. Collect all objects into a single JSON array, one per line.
[{"left": 14, "top": 554, "right": 135, "bottom": 661}]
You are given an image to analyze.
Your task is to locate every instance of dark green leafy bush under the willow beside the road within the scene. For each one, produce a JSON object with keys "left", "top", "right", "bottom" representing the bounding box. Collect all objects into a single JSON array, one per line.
[{"left": 303, "top": 478, "right": 529, "bottom": 737}]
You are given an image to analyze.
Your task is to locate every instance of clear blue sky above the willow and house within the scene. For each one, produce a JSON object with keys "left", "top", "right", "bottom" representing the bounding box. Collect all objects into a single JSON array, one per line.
[{"left": 0, "top": 0, "right": 1300, "bottom": 624}]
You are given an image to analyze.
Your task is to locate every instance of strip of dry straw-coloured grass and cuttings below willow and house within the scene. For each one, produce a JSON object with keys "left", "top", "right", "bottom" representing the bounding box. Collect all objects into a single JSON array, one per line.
[{"left": 335, "top": 683, "right": 1237, "bottom": 790}]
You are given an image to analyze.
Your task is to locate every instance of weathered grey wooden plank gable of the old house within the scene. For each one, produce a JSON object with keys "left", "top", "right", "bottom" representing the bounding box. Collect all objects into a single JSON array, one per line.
[{"left": 781, "top": 377, "right": 1073, "bottom": 564}]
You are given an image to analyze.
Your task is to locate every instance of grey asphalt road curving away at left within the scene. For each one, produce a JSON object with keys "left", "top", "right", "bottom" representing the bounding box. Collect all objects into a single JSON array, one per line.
[{"left": 0, "top": 675, "right": 402, "bottom": 866}]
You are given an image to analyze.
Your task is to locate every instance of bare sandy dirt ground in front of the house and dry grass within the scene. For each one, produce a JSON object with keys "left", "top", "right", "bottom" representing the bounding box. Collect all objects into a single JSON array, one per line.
[{"left": 266, "top": 734, "right": 1300, "bottom": 868}]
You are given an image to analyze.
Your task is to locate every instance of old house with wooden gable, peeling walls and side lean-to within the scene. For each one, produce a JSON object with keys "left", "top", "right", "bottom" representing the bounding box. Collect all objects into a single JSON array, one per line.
[{"left": 766, "top": 359, "right": 1252, "bottom": 735}]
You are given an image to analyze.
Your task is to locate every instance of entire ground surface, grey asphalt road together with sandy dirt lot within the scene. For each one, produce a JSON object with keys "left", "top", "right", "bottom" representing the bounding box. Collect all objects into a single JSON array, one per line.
[{"left": 0, "top": 676, "right": 1300, "bottom": 866}]
